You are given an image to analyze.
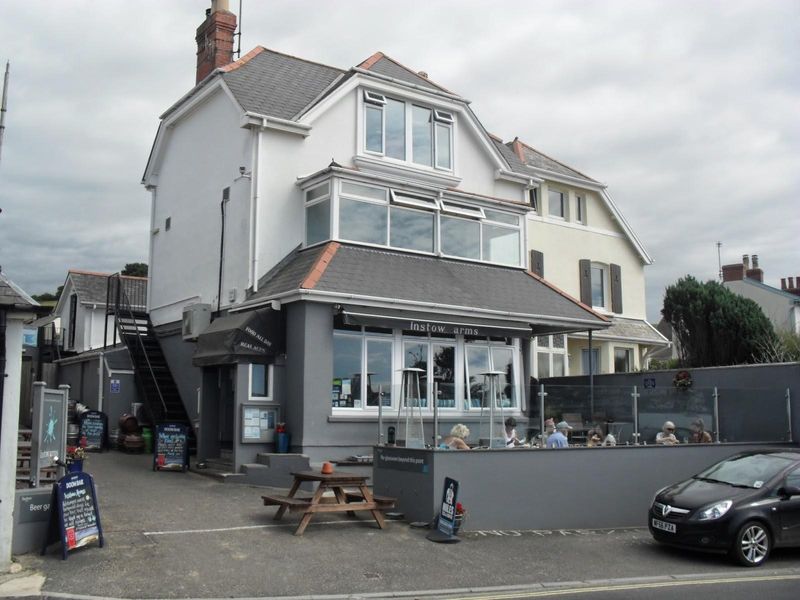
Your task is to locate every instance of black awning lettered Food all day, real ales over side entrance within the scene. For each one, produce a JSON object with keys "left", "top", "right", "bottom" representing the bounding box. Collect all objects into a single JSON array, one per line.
[{"left": 192, "top": 308, "right": 285, "bottom": 367}]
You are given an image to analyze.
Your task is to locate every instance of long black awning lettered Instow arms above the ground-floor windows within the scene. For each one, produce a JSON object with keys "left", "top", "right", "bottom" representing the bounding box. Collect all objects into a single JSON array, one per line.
[{"left": 342, "top": 306, "right": 531, "bottom": 337}]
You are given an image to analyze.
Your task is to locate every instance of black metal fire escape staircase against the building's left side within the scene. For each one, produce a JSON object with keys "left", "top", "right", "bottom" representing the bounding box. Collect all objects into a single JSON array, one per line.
[{"left": 105, "top": 273, "right": 193, "bottom": 428}]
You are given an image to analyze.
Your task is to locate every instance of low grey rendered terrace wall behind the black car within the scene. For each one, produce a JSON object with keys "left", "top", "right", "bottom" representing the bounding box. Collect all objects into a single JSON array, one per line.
[{"left": 373, "top": 444, "right": 792, "bottom": 530}]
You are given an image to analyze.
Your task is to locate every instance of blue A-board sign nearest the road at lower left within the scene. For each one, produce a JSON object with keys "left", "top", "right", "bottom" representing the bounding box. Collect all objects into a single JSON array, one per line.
[{"left": 42, "top": 473, "right": 103, "bottom": 560}]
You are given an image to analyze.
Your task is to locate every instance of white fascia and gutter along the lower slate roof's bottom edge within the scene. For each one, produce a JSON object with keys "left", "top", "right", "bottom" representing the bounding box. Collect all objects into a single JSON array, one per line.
[{"left": 230, "top": 289, "right": 611, "bottom": 330}]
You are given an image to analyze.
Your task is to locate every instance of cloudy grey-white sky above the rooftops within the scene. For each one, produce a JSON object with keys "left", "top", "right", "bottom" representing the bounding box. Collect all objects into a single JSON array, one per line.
[{"left": 0, "top": 0, "right": 800, "bottom": 320}]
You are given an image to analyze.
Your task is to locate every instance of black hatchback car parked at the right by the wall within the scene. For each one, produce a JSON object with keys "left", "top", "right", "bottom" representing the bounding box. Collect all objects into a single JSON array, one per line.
[{"left": 648, "top": 450, "right": 800, "bottom": 567}]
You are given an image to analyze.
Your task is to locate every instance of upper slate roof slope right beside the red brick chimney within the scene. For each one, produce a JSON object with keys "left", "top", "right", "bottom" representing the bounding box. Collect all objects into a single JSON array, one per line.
[{"left": 221, "top": 46, "right": 345, "bottom": 119}]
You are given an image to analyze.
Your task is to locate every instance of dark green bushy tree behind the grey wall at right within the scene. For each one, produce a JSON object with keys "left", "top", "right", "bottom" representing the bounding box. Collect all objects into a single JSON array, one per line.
[{"left": 661, "top": 275, "right": 776, "bottom": 367}]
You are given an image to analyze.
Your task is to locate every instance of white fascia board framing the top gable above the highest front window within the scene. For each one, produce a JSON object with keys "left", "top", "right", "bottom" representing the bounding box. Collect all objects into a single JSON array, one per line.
[{"left": 299, "top": 69, "right": 508, "bottom": 171}]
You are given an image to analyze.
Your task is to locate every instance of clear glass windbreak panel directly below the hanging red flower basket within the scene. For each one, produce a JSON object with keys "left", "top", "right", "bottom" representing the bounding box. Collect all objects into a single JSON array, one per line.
[{"left": 639, "top": 386, "right": 716, "bottom": 444}]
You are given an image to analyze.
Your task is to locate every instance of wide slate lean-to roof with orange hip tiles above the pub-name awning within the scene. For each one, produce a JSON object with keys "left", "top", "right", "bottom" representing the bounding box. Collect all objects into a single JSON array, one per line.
[{"left": 248, "top": 242, "right": 607, "bottom": 329}]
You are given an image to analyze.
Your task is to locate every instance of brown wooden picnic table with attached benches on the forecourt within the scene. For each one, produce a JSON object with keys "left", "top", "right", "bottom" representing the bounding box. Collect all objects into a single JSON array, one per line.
[{"left": 261, "top": 471, "right": 394, "bottom": 535}]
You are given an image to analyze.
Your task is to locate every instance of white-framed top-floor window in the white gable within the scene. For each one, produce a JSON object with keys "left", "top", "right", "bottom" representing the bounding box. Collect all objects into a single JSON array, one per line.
[{"left": 363, "top": 90, "right": 455, "bottom": 171}]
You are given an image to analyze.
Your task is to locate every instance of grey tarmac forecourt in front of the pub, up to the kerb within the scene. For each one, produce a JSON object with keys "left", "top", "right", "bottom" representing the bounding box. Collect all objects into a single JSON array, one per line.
[{"left": 0, "top": 452, "right": 800, "bottom": 598}]
